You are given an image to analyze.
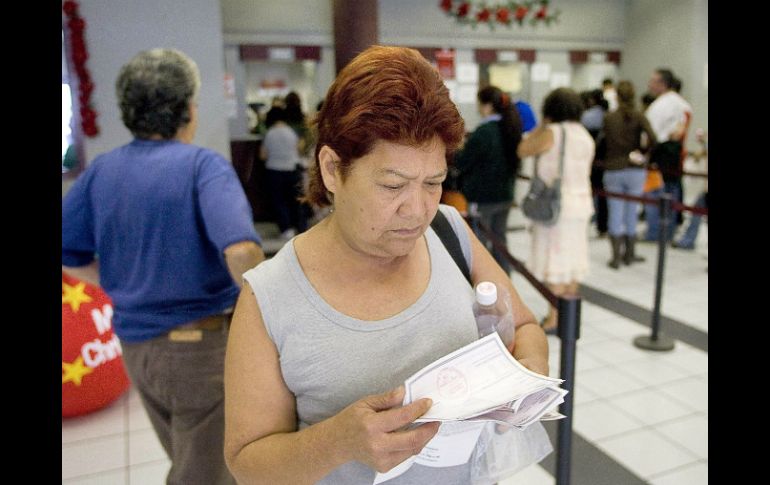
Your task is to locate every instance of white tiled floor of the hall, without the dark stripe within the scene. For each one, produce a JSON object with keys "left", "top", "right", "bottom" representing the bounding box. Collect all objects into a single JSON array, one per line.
[{"left": 62, "top": 195, "right": 708, "bottom": 485}]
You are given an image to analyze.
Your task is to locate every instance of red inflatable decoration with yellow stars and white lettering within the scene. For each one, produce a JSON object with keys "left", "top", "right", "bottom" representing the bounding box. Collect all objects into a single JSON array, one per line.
[{"left": 61, "top": 273, "right": 129, "bottom": 417}]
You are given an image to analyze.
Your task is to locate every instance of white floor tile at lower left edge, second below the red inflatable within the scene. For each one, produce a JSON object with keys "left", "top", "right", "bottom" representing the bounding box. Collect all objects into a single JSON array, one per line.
[{"left": 61, "top": 434, "right": 127, "bottom": 479}]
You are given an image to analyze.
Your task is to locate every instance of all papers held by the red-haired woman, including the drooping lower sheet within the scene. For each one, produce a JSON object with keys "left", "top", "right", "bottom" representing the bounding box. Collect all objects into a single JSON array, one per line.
[{"left": 373, "top": 332, "right": 567, "bottom": 485}]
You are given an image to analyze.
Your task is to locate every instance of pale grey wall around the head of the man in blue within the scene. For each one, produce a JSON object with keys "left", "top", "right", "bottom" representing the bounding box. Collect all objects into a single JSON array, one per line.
[{"left": 79, "top": 0, "right": 230, "bottom": 163}]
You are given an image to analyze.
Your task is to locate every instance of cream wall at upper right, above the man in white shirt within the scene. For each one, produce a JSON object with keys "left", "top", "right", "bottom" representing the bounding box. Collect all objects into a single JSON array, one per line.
[{"left": 621, "top": 0, "right": 708, "bottom": 140}]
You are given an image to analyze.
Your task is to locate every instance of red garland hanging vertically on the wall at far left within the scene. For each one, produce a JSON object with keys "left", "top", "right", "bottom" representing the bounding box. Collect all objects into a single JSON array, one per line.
[{"left": 62, "top": 0, "right": 99, "bottom": 137}]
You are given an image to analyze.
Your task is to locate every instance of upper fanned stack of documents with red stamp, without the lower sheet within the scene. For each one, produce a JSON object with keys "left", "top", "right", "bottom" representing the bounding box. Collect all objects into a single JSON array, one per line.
[{"left": 404, "top": 332, "right": 567, "bottom": 429}]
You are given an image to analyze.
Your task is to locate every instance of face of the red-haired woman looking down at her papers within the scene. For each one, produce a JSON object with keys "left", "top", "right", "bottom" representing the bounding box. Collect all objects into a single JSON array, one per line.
[{"left": 333, "top": 137, "right": 447, "bottom": 257}]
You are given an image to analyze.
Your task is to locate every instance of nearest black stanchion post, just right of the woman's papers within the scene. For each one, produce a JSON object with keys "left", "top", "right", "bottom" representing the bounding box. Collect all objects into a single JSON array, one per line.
[{"left": 556, "top": 296, "right": 580, "bottom": 485}]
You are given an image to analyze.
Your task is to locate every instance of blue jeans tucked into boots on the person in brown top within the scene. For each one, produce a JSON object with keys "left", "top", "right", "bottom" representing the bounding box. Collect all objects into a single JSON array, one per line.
[{"left": 604, "top": 168, "right": 647, "bottom": 237}]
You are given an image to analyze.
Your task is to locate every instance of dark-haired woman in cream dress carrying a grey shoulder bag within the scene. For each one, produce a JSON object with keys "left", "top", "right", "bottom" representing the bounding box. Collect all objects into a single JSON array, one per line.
[{"left": 518, "top": 88, "right": 595, "bottom": 333}]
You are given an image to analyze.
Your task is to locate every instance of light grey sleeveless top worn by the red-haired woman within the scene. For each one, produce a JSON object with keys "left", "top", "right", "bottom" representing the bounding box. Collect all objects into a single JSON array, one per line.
[{"left": 243, "top": 205, "right": 548, "bottom": 485}]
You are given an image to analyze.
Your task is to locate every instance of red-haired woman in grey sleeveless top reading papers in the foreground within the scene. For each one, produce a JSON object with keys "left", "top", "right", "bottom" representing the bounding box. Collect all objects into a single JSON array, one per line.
[{"left": 225, "top": 46, "right": 548, "bottom": 484}]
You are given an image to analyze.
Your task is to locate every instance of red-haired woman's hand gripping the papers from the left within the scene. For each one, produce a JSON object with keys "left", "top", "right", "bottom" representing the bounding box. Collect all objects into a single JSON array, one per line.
[{"left": 331, "top": 386, "right": 440, "bottom": 473}]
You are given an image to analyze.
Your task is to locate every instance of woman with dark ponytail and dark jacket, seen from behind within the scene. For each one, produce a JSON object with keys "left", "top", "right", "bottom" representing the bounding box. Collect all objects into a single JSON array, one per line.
[{"left": 455, "top": 86, "right": 522, "bottom": 272}]
